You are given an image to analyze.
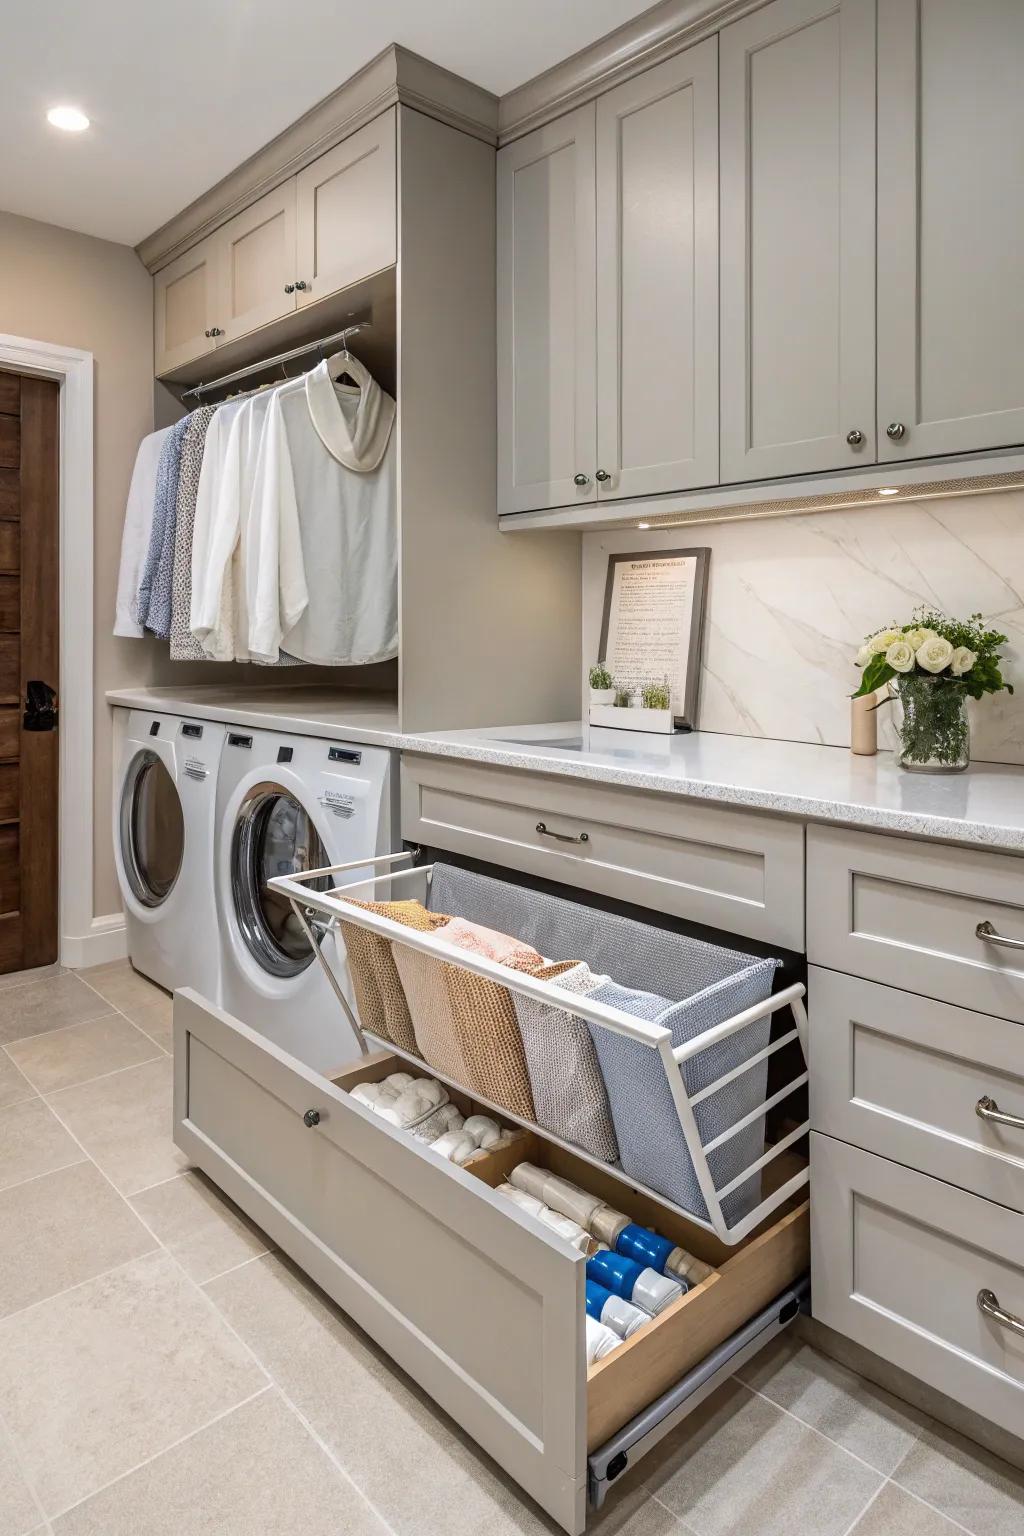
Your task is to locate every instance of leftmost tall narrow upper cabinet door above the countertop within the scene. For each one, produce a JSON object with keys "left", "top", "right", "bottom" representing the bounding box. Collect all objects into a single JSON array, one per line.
[{"left": 497, "top": 103, "right": 599, "bottom": 513}]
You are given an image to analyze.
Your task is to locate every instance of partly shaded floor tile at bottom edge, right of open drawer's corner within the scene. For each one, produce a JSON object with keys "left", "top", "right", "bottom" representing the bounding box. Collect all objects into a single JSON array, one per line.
[{"left": 642, "top": 1382, "right": 883, "bottom": 1536}]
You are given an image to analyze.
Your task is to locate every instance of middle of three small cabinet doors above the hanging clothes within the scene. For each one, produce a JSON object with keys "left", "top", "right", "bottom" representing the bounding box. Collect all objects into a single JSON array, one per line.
[{"left": 213, "top": 178, "right": 296, "bottom": 341}]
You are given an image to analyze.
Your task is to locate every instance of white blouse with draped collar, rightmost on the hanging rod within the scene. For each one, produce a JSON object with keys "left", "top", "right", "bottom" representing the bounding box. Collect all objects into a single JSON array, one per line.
[{"left": 246, "top": 362, "right": 398, "bottom": 667}]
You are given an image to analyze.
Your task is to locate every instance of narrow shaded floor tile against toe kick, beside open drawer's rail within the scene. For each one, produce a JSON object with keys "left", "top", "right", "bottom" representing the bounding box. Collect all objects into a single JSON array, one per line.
[{"left": 740, "top": 1335, "right": 924, "bottom": 1476}]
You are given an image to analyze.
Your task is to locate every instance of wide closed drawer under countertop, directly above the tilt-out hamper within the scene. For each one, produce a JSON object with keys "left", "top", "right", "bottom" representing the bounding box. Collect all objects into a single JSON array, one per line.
[{"left": 402, "top": 754, "right": 803, "bottom": 951}]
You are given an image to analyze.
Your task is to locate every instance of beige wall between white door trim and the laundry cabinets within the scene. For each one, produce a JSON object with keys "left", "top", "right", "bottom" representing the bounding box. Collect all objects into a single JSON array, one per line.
[{"left": 0, "top": 214, "right": 160, "bottom": 915}]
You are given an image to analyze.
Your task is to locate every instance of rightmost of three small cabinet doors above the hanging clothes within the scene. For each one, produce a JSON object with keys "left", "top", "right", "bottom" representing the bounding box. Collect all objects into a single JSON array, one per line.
[{"left": 295, "top": 108, "right": 398, "bottom": 307}]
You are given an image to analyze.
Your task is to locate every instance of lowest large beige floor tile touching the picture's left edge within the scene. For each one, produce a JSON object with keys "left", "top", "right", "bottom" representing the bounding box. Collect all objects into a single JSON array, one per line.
[{"left": 0, "top": 1253, "right": 267, "bottom": 1531}]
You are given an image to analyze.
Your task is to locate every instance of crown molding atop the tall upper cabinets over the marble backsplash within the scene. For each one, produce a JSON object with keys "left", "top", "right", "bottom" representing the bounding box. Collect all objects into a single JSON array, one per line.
[{"left": 497, "top": 0, "right": 766, "bottom": 144}]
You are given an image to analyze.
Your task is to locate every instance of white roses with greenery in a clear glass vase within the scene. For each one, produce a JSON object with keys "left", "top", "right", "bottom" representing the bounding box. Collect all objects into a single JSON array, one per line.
[{"left": 854, "top": 608, "right": 1013, "bottom": 773}]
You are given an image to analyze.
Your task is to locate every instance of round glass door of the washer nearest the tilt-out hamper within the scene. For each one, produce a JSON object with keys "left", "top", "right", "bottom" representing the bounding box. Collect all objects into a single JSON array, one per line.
[{"left": 232, "top": 783, "right": 332, "bottom": 977}]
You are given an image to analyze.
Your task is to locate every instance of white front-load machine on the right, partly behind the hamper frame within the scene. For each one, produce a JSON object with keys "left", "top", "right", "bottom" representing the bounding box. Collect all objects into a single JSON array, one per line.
[{"left": 215, "top": 727, "right": 398, "bottom": 1071}]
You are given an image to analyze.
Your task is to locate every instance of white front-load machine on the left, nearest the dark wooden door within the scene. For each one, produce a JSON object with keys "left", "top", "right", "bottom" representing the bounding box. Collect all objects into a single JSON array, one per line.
[{"left": 114, "top": 710, "right": 226, "bottom": 1001}]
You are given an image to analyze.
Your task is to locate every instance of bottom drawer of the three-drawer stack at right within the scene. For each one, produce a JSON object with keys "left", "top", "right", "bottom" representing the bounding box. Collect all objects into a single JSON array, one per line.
[{"left": 811, "top": 1132, "right": 1024, "bottom": 1435}]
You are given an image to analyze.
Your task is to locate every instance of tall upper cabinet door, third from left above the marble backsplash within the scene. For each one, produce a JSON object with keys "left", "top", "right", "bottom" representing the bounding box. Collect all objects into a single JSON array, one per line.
[{"left": 718, "top": 0, "right": 878, "bottom": 482}]
